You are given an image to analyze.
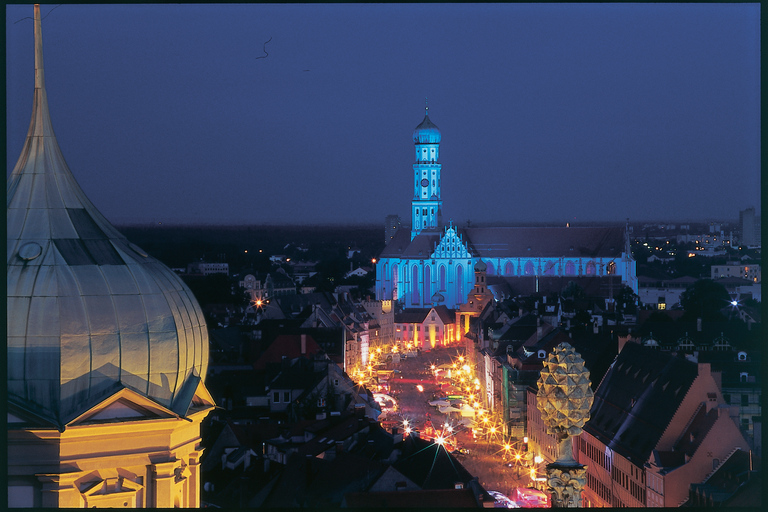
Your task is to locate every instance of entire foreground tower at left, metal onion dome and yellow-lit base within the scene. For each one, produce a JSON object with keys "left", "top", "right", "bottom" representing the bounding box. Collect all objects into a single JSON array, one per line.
[{"left": 6, "top": 5, "right": 214, "bottom": 508}]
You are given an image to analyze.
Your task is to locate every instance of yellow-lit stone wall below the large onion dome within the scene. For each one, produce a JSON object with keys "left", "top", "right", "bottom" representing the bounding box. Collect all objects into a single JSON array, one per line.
[{"left": 7, "top": 409, "right": 210, "bottom": 508}]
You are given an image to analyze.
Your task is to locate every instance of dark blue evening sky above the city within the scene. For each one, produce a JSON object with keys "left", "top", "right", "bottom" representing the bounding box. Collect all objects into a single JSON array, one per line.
[{"left": 6, "top": 4, "right": 760, "bottom": 224}]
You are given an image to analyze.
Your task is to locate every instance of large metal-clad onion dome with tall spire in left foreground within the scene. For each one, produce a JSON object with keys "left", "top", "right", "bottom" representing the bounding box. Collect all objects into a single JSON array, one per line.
[{"left": 6, "top": 5, "right": 208, "bottom": 429}]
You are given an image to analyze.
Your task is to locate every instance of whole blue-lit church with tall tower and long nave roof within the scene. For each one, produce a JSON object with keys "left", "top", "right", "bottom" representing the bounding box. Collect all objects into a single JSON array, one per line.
[{"left": 376, "top": 108, "right": 637, "bottom": 308}]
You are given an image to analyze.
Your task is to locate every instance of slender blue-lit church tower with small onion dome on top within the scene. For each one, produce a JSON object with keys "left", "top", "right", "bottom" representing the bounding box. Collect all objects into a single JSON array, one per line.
[{"left": 411, "top": 106, "right": 443, "bottom": 240}]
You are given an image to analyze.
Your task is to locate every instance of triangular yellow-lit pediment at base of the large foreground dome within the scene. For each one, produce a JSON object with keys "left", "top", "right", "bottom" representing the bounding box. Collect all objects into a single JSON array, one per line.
[{"left": 67, "top": 388, "right": 177, "bottom": 427}]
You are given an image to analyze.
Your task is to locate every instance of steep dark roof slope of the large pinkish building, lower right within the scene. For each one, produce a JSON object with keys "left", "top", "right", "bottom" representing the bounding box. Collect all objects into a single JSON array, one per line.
[{"left": 584, "top": 343, "right": 698, "bottom": 464}]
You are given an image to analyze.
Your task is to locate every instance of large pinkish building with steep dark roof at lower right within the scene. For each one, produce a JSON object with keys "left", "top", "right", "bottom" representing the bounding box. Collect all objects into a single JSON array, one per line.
[{"left": 574, "top": 343, "right": 749, "bottom": 507}]
